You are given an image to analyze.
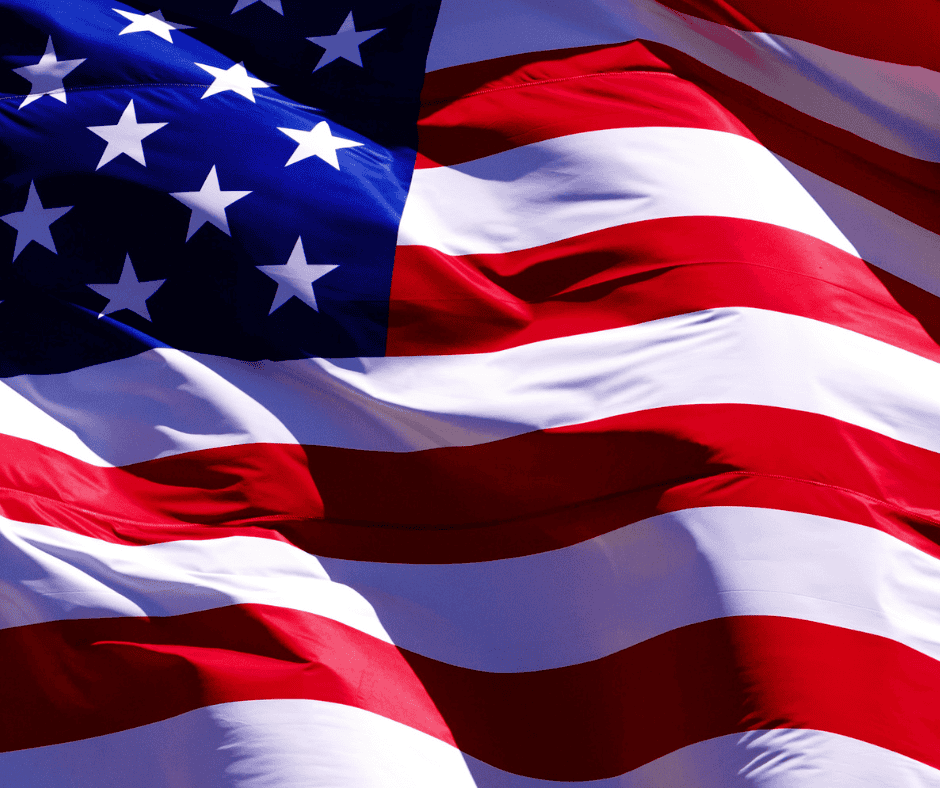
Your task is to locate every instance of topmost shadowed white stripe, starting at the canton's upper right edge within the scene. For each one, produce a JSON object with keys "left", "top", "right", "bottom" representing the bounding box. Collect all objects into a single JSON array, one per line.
[{"left": 427, "top": 0, "right": 940, "bottom": 161}]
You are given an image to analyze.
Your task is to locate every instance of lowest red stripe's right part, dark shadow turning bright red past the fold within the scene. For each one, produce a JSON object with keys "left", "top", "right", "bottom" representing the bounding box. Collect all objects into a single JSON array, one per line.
[{"left": 408, "top": 616, "right": 940, "bottom": 781}]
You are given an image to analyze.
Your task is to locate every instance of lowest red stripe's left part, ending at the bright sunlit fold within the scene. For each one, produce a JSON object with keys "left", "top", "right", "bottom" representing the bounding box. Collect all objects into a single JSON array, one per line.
[{"left": 0, "top": 605, "right": 453, "bottom": 751}]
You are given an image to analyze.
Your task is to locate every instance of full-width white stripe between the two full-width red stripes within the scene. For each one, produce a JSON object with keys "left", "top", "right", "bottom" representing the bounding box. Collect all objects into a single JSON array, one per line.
[{"left": 11, "top": 507, "right": 940, "bottom": 673}]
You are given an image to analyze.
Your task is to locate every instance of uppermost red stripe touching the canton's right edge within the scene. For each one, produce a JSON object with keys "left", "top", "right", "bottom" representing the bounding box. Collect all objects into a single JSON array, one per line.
[{"left": 417, "top": 42, "right": 940, "bottom": 237}]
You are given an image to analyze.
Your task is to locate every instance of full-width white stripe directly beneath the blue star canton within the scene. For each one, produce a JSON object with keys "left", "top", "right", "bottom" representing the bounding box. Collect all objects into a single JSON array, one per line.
[{"left": 0, "top": 307, "right": 940, "bottom": 465}]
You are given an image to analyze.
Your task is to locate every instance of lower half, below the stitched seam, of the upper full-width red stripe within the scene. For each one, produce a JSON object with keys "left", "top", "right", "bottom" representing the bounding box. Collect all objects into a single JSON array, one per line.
[{"left": 0, "top": 450, "right": 940, "bottom": 564}]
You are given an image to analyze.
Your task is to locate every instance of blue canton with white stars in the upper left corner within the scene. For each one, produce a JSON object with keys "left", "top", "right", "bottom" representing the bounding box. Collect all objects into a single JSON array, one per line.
[{"left": 0, "top": 0, "right": 438, "bottom": 376}]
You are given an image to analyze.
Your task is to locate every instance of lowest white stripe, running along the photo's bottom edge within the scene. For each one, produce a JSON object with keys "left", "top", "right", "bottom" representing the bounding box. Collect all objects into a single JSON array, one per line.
[{"left": 0, "top": 700, "right": 940, "bottom": 788}]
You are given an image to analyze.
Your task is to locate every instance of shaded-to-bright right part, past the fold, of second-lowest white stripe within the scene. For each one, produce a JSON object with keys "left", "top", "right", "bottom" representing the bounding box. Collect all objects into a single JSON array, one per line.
[{"left": 322, "top": 507, "right": 940, "bottom": 673}]
